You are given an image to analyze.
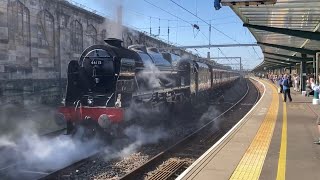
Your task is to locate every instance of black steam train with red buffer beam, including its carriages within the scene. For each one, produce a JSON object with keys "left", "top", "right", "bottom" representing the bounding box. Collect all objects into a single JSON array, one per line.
[{"left": 55, "top": 38, "right": 239, "bottom": 133}]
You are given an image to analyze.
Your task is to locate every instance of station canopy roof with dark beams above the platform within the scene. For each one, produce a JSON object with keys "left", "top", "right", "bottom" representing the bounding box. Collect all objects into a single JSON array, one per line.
[{"left": 221, "top": 0, "right": 320, "bottom": 70}]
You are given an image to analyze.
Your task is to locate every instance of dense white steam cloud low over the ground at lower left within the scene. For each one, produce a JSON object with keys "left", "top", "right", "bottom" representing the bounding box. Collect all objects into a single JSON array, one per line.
[{"left": 0, "top": 129, "right": 101, "bottom": 172}]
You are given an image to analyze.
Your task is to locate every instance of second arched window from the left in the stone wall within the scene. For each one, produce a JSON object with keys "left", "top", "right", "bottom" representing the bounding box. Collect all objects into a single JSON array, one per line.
[{"left": 37, "top": 10, "right": 54, "bottom": 48}]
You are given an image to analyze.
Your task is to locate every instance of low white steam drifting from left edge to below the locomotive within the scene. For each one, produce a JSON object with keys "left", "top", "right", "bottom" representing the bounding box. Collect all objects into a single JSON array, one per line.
[{"left": 0, "top": 101, "right": 167, "bottom": 179}]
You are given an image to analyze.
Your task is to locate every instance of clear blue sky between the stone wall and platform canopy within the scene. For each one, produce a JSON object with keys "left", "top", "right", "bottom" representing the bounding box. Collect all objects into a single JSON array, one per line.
[{"left": 70, "top": 0, "right": 263, "bottom": 69}]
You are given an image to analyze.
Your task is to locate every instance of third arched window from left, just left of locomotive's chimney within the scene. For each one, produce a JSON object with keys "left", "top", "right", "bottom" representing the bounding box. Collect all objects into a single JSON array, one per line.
[{"left": 70, "top": 20, "right": 83, "bottom": 53}]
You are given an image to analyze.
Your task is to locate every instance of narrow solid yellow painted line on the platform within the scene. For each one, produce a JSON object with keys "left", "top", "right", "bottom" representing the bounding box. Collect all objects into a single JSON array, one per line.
[{"left": 277, "top": 103, "right": 287, "bottom": 180}]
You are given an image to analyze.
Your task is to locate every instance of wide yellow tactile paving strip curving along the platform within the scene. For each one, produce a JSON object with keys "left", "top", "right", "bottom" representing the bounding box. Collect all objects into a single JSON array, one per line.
[{"left": 230, "top": 83, "right": 279, "bottom": 180}]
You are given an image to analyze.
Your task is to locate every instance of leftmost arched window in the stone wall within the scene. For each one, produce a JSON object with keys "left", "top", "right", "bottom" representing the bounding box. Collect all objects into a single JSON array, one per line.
[{"left": 8, "top": 0, "right": 30, "bottom": 46}]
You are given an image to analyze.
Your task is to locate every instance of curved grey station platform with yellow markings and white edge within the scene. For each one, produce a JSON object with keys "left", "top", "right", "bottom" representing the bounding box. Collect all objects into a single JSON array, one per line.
[{"left": 177, "top": 79, "right": 320, "bottom": 180}]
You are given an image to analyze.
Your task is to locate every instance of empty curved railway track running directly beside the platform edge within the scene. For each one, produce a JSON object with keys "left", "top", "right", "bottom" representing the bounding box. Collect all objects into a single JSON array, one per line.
[{"left": 120, "top": 78, "right": 260, "bottom": 180}]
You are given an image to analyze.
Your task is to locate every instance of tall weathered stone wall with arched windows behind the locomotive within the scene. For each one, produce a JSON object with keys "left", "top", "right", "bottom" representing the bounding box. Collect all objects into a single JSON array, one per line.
[{"left": 0, "top": 0, "right": 194, "bottom": 105}]
